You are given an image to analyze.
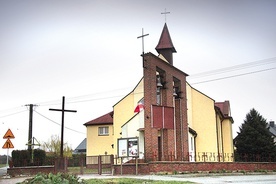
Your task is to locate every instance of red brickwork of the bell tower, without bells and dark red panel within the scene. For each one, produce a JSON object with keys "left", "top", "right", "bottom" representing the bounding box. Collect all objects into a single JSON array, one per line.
[{"left": 143, "top": 53, "right": 188, "bottom": 161}]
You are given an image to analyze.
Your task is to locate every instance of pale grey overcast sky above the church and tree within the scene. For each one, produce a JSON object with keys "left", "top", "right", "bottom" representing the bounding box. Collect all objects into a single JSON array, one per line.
[{"left": 0, "top": 0, "right": 276, "bottom": 154}]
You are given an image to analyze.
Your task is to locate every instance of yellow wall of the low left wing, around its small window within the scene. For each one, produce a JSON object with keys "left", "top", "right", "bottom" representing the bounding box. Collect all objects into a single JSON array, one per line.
[{"left": 86, "top": 125, "right": 113, "bottom": 156}]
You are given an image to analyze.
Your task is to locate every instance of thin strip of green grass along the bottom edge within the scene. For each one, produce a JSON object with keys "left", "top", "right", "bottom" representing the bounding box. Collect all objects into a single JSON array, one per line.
[{"left": 86, "top": 178, "right": 193, "bottom": 184}]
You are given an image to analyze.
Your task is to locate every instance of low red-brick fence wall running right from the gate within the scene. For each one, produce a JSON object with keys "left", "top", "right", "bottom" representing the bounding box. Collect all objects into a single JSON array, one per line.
[{"left": 114, "top": 161, "right": 276, "bottom": 175}]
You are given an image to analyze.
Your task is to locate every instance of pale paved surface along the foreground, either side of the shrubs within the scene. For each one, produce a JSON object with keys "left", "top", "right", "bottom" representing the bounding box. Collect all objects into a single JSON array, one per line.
[{"left": 0, "top": 168, "right": 276, "bottom": 184}]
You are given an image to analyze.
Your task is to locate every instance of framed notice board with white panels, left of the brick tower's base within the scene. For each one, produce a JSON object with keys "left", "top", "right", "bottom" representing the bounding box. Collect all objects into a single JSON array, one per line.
[{"left": 118, "top": 137, "right": 139, "bottom": 157}]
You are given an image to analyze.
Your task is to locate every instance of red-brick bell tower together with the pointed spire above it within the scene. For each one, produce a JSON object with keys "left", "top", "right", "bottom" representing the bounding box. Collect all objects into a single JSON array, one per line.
[{"left": 143, "top": 23, "right": 189, "bottom": 161}]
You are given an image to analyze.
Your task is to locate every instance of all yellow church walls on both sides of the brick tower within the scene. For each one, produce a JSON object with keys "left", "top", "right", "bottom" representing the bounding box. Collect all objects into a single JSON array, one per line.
[{"left": 87, "top": 79, "right": 233, "bottom": 161}]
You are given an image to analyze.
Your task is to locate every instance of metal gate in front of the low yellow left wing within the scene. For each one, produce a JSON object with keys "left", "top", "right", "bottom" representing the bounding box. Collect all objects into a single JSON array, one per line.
[{"left": 86, "top": 155, "right": 114, "bottom": 175}]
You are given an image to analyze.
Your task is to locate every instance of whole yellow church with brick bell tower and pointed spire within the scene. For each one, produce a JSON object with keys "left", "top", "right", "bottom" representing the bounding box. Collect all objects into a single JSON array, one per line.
[{"left": 84, "top": 23, "right": 234, "bottom": 162}]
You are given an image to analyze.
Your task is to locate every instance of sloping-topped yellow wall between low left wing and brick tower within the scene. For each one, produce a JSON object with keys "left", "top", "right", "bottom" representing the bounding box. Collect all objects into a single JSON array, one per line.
[{"left": 113, "top": 79, "right": 144, "bottom": 155}]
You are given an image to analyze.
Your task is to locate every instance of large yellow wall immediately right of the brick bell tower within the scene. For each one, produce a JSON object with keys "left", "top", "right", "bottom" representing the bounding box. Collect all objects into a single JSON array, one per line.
[{"left": 188, "top": 88, "right": 218, "bottom": 154}]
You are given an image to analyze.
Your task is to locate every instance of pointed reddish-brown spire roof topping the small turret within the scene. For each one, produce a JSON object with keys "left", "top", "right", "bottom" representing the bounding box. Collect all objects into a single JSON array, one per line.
[{"left": 155, "top": 23, "right": 176, "bottom": 52}]
